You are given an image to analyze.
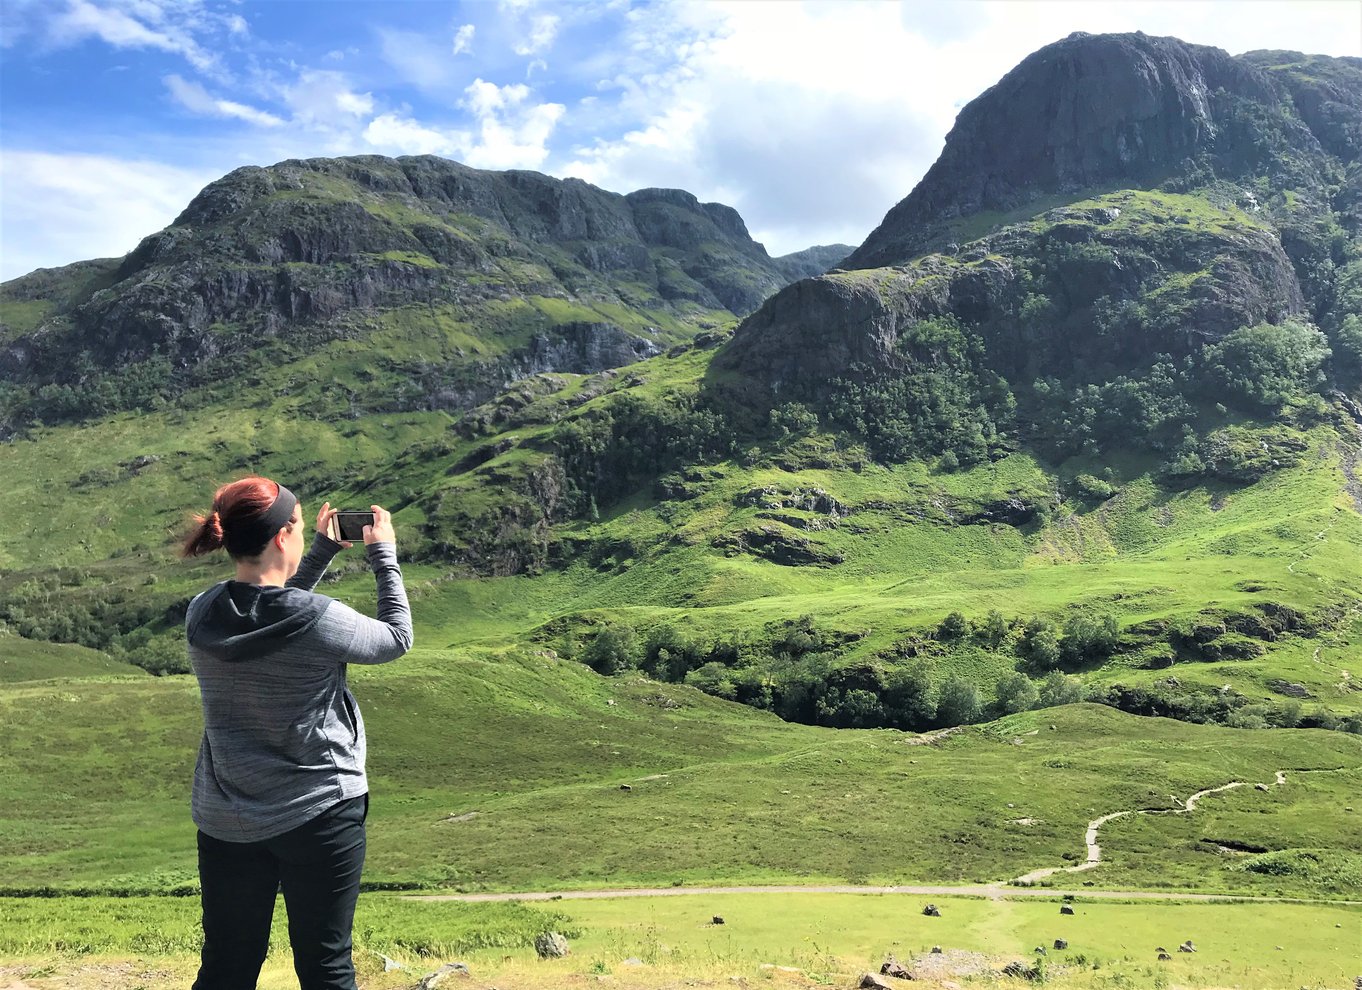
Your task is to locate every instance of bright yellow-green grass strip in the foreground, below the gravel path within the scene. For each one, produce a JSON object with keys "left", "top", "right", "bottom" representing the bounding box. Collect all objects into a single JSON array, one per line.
[{"left": 0, "top": 891, "right": 1362, "bottom": 990}]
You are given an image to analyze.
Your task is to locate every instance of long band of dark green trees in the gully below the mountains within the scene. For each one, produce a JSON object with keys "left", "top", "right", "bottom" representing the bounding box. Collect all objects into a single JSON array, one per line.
[{"left": 577, "top": 610, "right": 1362, "bottom": 733}]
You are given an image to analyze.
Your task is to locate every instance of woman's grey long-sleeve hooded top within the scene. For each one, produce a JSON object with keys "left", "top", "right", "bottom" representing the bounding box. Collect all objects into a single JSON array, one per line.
[{"left": 185, "top": 534, "right": 411, "bottom": 842}]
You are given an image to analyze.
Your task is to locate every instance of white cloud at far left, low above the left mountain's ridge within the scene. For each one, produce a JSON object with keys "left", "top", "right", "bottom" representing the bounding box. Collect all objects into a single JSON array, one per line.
[{"left": 0, "top": 150, "right": 218, "bottom": 279}]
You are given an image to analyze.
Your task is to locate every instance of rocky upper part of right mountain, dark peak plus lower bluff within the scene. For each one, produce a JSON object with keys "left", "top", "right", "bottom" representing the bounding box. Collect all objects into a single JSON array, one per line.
[{"left": 716, "top": 34, "right": 1362, "bottom": 404}]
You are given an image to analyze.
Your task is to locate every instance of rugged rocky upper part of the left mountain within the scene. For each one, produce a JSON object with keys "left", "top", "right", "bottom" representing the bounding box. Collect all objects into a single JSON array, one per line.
[{"left": 0, "top": 157, "right": 800, "bottom": 430}]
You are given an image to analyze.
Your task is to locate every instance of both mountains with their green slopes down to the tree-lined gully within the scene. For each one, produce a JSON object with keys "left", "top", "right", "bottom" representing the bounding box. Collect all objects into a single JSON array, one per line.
[{"left": 0, "top": 34, "right": 1362, "bottom": 729}]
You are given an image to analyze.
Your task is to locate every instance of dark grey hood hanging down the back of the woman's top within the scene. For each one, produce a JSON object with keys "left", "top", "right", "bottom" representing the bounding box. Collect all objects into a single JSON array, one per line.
[{"left": 187, "top": 581, "right": 331, "bottom": 660}]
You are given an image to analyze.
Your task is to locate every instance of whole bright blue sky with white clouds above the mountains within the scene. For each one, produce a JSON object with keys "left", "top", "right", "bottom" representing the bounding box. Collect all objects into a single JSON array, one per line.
[{"left": 0, "top": 0, "right": 1362, "bottom": 278}]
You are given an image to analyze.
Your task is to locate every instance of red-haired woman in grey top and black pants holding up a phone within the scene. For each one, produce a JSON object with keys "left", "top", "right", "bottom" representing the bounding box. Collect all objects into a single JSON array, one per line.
[{"left": 184, "top": 478, "right": 411, "bottom": 990}]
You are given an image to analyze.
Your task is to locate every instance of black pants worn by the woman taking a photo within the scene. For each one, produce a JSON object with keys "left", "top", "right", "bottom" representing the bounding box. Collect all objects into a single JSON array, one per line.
[{"left": 193, "top": 794, "right": 369, "bottom": 990}]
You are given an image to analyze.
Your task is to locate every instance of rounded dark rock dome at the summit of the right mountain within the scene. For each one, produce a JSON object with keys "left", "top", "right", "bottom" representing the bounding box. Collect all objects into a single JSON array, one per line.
[{"left": 846, "top": 33, "right": 1279, "bottom": 268}]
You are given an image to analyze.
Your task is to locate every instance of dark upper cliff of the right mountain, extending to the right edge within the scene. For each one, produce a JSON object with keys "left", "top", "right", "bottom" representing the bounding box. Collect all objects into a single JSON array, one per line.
[{"left": 844, "top": 33, "right": 1362, "bottom": 268}]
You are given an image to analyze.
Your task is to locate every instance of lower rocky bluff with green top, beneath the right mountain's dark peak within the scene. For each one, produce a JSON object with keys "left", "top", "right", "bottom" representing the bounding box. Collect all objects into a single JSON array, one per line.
[{"left": 718, "top": 192, "right": 1305, "bottom": 399}]
